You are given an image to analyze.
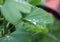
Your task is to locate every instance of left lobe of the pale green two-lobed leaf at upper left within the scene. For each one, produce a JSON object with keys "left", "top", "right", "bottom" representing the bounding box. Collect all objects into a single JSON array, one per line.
[{"left": 1, "top": 3, "right": 22, "bottom": 25}]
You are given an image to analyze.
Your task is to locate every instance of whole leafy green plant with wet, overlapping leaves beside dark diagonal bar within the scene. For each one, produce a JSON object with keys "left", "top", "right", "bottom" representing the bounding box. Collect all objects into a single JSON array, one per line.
[{"left": 0, "top": 0, "right": 59, "bottom": 42}]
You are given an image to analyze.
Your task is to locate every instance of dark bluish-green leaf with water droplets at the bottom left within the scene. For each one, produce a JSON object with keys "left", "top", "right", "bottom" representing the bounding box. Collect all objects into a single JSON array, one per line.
[{"left": 0, "top": 27, "right": 32, "bottom": 42}]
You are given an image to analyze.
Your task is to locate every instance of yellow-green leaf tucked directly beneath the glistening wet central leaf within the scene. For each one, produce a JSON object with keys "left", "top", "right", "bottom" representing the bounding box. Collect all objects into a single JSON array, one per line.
[{"left": 24, "top": 22, "right": 42, "bottom": 33}]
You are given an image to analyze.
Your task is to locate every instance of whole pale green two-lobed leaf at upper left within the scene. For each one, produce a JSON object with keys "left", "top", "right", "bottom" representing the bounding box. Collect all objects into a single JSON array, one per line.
[{"left": 1, "top": 0, "right": 31, "bottom": 25}]
